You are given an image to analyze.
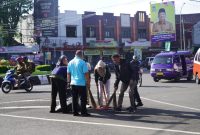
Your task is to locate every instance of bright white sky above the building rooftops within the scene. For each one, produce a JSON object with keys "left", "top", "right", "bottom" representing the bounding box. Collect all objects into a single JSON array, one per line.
[{"left": 59, "top": 0, "right": 200, "bottom": 16}]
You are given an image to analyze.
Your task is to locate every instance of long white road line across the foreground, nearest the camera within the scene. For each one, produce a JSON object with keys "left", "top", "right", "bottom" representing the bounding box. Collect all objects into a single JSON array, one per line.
[{"left": 0, "top": 114, "right": 200, "bottom": 135}]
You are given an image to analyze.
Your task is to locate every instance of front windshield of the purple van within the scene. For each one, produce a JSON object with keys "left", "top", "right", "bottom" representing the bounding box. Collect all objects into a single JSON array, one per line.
[{"left": 153, "top": 56, "right": 172, "bottom": 64}]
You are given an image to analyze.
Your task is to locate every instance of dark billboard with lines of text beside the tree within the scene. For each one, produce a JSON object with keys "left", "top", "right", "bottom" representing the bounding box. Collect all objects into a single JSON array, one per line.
[{"left": 34, "top": 0, "right": 58, "bottom": 37}]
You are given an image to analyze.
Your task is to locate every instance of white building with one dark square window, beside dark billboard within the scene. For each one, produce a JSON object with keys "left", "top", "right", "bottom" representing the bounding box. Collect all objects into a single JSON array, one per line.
[{"left": 41, "top": 10, "right": 83, "bottom": 47}]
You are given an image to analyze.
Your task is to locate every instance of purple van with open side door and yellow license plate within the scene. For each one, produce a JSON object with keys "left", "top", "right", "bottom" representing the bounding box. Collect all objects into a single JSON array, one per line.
[{"left": 150, "top": 51, "right": 193, "bottom": 82}]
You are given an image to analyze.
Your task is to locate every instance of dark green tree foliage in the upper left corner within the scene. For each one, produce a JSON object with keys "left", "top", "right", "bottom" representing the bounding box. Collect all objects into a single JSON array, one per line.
[{"left": 0, "top": 0, "right": 33, "bottom": 46}]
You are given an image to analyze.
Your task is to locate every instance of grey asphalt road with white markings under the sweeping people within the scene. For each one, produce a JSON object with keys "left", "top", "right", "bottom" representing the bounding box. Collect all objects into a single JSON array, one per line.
[{"left": 0, "top": 74, "right": 200, "bottom": 135}]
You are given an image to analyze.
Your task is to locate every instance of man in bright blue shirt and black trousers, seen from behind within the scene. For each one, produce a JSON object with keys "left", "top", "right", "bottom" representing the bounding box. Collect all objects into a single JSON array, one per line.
[{"left": 67, "top": 50, "right": 90, "bottom": 116}]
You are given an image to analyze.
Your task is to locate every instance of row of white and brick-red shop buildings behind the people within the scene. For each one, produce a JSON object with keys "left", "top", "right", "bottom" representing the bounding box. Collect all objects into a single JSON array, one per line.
[{"left": 30, "top": 8, "right": 200, "bottom": 63}]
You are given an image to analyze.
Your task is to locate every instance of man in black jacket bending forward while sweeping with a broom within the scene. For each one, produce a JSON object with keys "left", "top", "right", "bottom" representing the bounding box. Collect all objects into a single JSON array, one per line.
[{"left": 112, "top": 54, "right": 137, "bottom": 112}]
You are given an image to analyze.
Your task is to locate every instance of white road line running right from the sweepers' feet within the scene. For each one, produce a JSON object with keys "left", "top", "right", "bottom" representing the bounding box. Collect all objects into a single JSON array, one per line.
[{"left": 141, "top": 97, "right": 200, "bottom": 112}]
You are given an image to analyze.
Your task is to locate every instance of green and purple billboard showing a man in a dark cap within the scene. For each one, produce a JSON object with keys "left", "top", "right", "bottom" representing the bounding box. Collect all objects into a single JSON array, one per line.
[{"left": 150, "top": 1, "right": 176, "bottom": 42}]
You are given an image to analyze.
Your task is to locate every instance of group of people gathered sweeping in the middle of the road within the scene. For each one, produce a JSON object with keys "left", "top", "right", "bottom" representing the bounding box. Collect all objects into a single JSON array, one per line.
[{"left": 50, "top": 50, "right": 143, "bottom": 116}]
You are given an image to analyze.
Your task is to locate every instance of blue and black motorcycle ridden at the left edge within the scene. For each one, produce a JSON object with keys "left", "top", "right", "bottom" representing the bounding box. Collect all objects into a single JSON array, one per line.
[{"left": 1, "top": 70, "right": 33, "bottom": 93}]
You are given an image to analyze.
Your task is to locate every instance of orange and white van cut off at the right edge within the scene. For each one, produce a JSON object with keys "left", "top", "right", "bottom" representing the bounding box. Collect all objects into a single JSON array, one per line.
[{"left": 193, "top": 48, "right": 200, "bottom": 84}]
